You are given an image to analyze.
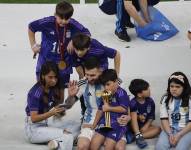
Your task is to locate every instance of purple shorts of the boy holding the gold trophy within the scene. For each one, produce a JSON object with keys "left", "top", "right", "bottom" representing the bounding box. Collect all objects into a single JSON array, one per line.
[{"left": 95, "top": 126, "right": 127, "bottom": 142}]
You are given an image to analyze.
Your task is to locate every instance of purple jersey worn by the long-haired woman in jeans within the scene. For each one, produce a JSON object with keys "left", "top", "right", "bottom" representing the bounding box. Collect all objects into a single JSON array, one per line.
[{"left": 25, "top": 83, "right": 54, "bottom": 116}]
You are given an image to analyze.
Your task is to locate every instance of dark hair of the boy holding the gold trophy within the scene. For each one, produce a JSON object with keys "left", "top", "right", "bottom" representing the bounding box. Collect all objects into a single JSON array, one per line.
[{"left": 100, "top": 69, "right": 118, "bottom": 85}]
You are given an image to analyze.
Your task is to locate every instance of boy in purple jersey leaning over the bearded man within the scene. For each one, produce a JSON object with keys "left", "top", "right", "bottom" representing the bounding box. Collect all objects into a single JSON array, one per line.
[{"left": 72, "top": 33, "right": 120, "bottom": 77}]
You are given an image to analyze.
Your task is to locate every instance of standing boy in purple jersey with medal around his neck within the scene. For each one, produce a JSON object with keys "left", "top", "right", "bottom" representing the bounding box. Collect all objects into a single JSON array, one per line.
[{"left": 28, "top": 1, "right": 90, "bottom": 100}]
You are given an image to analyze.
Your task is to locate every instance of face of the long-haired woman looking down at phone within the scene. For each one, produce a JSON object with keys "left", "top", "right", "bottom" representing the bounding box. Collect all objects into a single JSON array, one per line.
[{"left": 43, "top": 71, "right": 58, "bottom": 87}]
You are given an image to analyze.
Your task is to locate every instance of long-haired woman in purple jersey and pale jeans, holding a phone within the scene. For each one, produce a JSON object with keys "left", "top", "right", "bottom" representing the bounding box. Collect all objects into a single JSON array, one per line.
[{"left": 25, "top": 62, "right": 79, "bottom": 150}]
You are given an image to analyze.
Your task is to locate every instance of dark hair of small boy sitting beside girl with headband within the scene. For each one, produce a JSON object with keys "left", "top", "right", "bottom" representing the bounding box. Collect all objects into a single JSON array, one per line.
[{"left": 129, "top": 79, "right": 149, "bottom": 97}]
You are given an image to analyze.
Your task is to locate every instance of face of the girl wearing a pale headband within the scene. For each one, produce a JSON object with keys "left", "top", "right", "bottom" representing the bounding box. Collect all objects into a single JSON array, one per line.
[{"left": 170, "top": 82, "right": 184, "bottom": 97}]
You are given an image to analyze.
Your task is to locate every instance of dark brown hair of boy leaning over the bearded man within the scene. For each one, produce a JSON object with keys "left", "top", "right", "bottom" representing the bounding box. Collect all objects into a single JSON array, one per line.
[{"left": 72, "top": 33, "right": 91, "bottom": 51}]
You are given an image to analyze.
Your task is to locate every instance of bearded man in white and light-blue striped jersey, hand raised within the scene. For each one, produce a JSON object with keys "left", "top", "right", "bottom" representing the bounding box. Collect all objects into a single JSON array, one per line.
[{"left": 65, "top": 57, "right": 130, "bottom": 150}]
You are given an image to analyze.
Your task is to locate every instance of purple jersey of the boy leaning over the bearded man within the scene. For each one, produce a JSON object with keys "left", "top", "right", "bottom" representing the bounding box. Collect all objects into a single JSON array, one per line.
[{"left": 73, "top": 39, "right": 117, "bottom": 70}]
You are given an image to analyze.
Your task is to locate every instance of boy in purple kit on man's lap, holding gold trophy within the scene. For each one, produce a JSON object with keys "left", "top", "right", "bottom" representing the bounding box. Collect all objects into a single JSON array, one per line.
[{"left": 90, "top": 69, "right": 130, "bottom": 150}]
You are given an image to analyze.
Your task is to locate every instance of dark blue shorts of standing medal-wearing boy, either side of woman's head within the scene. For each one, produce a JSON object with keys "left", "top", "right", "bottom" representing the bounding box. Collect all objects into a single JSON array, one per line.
[{"left": 36, "top": 72, "right": 70, "bottom": 89}]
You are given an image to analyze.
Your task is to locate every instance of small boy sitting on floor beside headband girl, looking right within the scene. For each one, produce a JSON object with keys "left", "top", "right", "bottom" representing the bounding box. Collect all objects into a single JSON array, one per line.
[{"left": 129, "top": 79, "right": 160, "bottom": 148}]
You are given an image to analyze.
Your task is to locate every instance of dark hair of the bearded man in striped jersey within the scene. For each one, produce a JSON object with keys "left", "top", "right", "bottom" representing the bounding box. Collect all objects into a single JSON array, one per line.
[{"left": 83, "top": 56, "right": 100, "bottom": 70}]
